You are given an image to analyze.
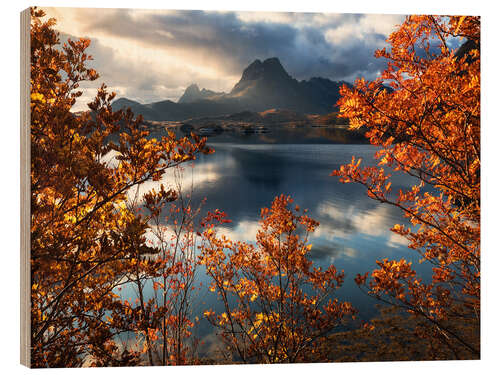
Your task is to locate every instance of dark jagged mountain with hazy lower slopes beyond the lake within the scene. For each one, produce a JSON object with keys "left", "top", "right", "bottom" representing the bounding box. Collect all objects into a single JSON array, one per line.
[{"left": 113, "top": 57, "right": 345, "bottom": 120}]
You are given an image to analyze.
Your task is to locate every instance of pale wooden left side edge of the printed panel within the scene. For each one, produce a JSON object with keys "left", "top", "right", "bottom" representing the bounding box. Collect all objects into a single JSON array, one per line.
[{"left": 20, "top": 8, "right": 31, "bottom": 367}]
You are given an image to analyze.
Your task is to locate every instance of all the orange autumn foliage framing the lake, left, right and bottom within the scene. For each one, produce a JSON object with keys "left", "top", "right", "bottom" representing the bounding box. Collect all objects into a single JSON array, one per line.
[{"left": 30, "top": 8, "right": 480, "bottom": 367}]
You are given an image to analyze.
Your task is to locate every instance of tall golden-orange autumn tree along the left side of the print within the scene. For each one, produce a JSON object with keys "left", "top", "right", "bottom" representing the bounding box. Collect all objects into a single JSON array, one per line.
[{"left": 30, "top": 8, "right": 209, "bottom": 367}]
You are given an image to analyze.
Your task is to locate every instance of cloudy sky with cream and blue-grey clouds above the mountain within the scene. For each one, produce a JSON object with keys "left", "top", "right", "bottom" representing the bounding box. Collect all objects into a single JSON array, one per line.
[{"left": 44, "top": 8, "right": 404, "bottom": 110}]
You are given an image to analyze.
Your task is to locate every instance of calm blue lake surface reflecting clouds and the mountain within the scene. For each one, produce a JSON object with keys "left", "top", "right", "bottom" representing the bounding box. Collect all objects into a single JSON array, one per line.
[{"left": 115, "top": 132, "right": 429, "bottom": 356}]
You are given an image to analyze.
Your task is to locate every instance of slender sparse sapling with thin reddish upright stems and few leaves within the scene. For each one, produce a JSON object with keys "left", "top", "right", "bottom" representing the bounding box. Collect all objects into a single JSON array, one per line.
[{"left": 145, "top": 171, "right": 205, "bottom": 365}]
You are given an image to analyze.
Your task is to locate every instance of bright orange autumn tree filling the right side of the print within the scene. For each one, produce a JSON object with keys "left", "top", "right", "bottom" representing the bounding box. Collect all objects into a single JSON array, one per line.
[{"left": 333, "top": 16, "right": 481, "bottom": 359}]
